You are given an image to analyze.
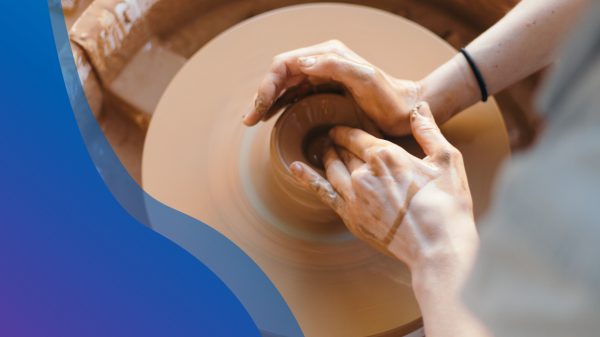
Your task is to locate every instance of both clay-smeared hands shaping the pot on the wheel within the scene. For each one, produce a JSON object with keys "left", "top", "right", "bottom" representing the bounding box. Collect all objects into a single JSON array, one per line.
[{"left": 244, "top": 41, "right": 477, "bottom": 273}]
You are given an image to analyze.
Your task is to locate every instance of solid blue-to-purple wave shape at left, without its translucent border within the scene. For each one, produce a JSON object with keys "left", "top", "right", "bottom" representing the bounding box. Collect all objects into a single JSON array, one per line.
[{"left": 0, "top": 0, "right": 270, "bottom": 337}]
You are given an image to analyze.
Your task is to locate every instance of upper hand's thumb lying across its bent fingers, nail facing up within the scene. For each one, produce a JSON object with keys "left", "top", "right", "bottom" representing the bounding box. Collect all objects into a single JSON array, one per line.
[{"left": 298, "top": 53, "right": 377, "bottom": 93}]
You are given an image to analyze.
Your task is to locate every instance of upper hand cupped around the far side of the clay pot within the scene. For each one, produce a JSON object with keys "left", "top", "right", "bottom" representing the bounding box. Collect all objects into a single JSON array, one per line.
[{"left": 244, "top": 40, "right": 420, "bottom": 136}]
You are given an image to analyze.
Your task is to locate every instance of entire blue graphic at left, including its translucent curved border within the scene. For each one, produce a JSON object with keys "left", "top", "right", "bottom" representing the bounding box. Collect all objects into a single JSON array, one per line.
[{"left": 0, "top": 0, "right": 302, "bottom": 337}]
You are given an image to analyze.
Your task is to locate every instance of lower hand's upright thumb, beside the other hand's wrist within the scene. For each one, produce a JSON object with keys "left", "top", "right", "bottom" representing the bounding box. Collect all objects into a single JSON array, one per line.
[{"left": 410, "top": 102, "right": 450, "bottom": 156}]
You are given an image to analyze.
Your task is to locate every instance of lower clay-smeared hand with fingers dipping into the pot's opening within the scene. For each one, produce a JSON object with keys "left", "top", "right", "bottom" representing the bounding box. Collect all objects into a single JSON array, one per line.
[{"left": 290, "top": 102, "right": 478, "bottom": 272}]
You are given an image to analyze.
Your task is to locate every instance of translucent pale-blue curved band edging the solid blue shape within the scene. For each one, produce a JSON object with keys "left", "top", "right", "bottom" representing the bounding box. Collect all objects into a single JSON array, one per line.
[{"left": 49, "top": 0, "right": 303, "bottom": 337}]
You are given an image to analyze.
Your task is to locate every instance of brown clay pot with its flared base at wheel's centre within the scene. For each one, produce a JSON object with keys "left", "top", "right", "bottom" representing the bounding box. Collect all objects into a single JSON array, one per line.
[{"left": 268, "top": 93, "right": 378, "bottom": 234}]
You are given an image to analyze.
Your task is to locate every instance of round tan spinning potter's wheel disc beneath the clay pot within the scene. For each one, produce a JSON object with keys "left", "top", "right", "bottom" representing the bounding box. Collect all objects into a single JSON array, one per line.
[{"left": 142, "top": 4, "right": 509, "bottom": 336}]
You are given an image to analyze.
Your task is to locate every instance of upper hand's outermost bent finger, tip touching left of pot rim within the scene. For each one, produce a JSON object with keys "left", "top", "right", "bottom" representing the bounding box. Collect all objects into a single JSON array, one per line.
[{"left": 243, "top": 41, "right": 347, "bottom": 126}]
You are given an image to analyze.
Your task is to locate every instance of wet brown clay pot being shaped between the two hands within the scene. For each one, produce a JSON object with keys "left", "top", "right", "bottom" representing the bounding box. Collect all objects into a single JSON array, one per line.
[{"left": 266, "top": 94, "right": 373, "bottom": 224}]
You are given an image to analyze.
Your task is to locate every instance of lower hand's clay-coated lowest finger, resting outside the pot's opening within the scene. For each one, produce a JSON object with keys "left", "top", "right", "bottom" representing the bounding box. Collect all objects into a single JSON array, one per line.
[{"left": 290, "top": 162, "right": 344, "bottom": 214}]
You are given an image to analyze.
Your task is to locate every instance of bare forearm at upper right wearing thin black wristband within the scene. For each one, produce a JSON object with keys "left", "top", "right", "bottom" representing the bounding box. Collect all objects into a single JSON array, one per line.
[{"left": 419, "top": 0, "right": 586, "bottom": 121}]
